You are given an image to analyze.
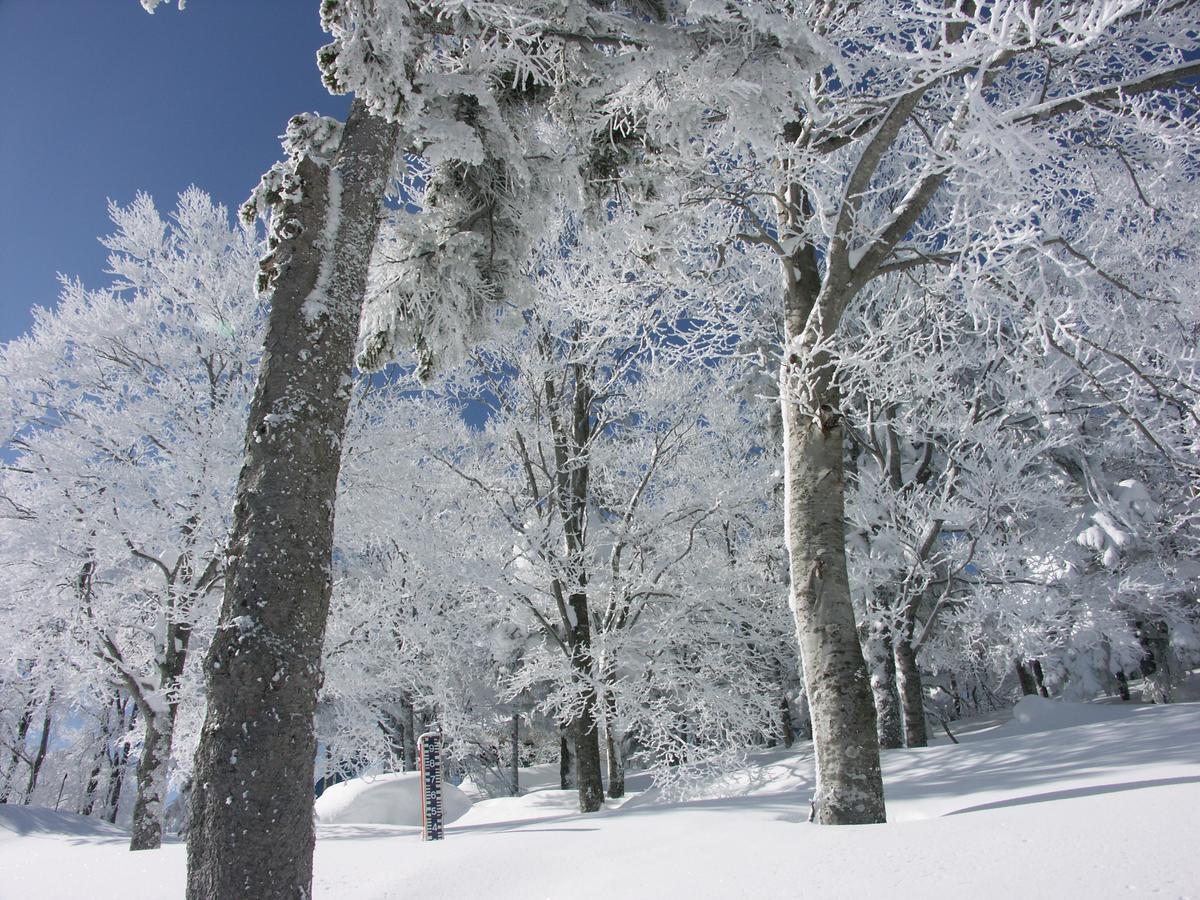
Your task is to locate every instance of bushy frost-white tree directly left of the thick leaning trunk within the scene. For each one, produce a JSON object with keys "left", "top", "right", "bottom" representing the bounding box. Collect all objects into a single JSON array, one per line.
[{"left": 0, "top": 188, "right": 263, "bottom": 850}]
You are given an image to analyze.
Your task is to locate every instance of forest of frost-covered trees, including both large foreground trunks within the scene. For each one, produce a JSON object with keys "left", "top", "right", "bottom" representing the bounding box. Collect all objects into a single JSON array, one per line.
[{"left": 0, "top": 0, "right": 1200, "bottom": 900}]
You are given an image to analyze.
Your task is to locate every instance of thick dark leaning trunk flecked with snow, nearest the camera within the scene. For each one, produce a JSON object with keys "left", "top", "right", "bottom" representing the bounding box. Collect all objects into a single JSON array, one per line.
[{"left": 187, "top": 101, "right": 397, "bottom": 900}]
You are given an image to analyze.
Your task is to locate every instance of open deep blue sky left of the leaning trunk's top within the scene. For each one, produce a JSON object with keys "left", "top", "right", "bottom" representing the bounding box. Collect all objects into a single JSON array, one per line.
[{"left": 0, "top": 0, "right": 349, "bottom": 342}]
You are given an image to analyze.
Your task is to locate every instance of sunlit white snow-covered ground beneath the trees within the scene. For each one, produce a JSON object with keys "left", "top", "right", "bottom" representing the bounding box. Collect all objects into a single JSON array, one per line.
[{"left": 0, "top": 698, "right": 1200, "bottom": 900}]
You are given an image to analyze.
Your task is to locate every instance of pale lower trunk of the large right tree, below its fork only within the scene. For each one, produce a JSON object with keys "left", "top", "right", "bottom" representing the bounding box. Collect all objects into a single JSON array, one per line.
[{"left": 780, "top": 374, "right": 886, "bottom": 824}]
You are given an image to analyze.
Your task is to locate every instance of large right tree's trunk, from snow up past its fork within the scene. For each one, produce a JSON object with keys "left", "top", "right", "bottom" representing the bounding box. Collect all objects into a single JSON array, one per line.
[{"left": 779, "top": 184, "right": 886, "bottom": 824}]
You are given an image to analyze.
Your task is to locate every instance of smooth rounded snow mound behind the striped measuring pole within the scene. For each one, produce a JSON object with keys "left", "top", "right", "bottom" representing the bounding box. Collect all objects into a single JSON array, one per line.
[{"left": 316, "top": 772, "right": 470, "bottom": 828}]
